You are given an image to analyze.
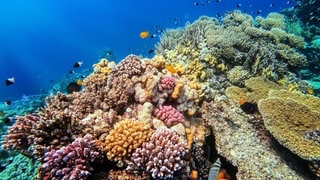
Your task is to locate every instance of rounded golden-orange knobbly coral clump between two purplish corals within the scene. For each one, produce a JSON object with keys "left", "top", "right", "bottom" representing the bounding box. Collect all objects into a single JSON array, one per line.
[{"left": 104, "top": 119, "right": 153, "bottom": 167}]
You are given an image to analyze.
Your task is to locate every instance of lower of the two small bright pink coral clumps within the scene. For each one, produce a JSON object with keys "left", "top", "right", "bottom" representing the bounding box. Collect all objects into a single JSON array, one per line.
[{"left": 153, "top": 105, "right": 184, "bottom": 127}]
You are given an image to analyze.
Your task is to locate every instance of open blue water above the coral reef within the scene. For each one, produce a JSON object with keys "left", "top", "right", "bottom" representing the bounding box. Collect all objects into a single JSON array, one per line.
[{"left": 0, "top": 0, "right": 294, "bottom": 101}]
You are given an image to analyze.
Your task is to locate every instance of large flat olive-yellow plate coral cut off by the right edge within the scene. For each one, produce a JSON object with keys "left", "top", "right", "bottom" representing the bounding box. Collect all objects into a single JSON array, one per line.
[{"left": 258, "top": 91, "right": 320, "bottom": 161}]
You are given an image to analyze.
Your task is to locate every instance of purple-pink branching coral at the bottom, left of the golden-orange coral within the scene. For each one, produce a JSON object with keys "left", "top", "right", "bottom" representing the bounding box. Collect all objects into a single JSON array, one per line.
[{"left": 40, "top": 134, "right": 99, "bottom": 179}]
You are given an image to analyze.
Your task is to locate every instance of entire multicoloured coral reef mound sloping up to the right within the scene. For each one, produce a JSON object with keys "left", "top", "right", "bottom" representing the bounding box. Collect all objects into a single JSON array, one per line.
[{"left": 2, "top": 11, "right": 320, "bottom": 179}]
